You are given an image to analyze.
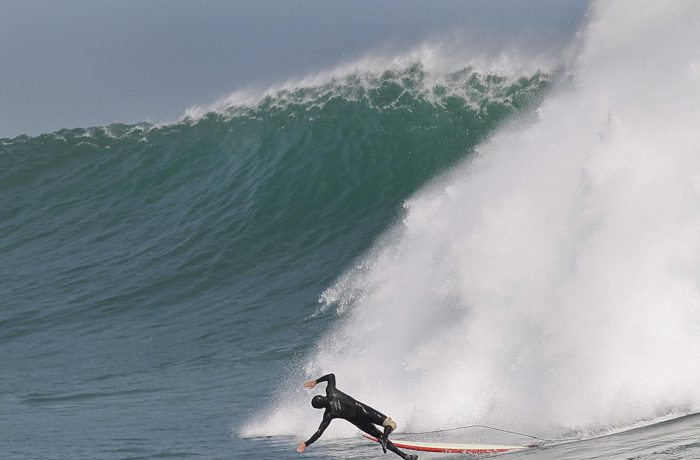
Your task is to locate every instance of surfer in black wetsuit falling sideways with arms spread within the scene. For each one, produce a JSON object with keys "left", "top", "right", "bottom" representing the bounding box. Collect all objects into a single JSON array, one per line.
[{"left": 297, "top": 374, "right": 418, "bottom": 460}]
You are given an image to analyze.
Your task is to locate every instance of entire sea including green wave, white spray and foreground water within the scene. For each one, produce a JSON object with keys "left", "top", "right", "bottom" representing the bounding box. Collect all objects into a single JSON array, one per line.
[{"left": 0, "top": 1, "right": 700, "bottom": 459}]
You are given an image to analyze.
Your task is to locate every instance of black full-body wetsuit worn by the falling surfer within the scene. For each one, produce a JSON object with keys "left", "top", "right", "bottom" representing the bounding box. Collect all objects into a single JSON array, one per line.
[{"left": 305, "top": 374, "right": 417, "bottom": 459}]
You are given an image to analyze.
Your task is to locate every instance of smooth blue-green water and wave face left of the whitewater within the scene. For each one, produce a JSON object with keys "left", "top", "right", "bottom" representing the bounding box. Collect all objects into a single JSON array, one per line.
[{"left": 0, "top": 66, "right": 549, "bottom": 459}]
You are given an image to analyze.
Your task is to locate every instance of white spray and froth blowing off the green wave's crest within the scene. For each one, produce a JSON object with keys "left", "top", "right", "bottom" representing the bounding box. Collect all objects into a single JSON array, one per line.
[{"left": 182, "top": 34, "right": 568, "bottom": 121}]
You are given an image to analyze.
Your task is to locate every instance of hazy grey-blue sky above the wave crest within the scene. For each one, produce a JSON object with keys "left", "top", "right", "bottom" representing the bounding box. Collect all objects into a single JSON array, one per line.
[{"left": 0, "top": 0, "right": 587, "bottom": 137}]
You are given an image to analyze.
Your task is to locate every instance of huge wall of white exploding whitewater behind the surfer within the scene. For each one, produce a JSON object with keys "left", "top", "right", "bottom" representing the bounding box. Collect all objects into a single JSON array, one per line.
[{"left": 247, "top": 1, "right": 700, "bottom": 436}]
